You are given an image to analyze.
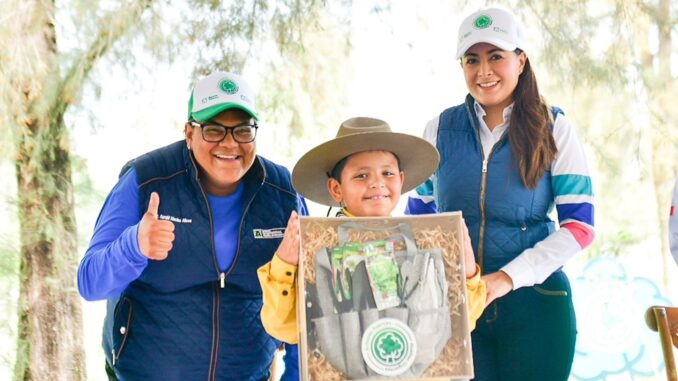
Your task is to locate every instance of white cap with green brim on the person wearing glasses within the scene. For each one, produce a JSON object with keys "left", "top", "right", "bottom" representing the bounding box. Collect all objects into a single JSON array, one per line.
[{"left": 188, "top": 71, "right": 259, "bottom": 122}]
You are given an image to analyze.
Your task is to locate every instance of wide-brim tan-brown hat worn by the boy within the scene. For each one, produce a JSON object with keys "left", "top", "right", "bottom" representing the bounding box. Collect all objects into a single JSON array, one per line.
[{"left": 292, "top": 117, "right": 440, "bottom": 206}]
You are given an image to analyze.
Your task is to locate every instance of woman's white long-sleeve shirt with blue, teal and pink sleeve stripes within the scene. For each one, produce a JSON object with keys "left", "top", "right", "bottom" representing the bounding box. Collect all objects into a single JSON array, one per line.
[{"left": 408, "top": 102, "right": 594, "bottom": 289}]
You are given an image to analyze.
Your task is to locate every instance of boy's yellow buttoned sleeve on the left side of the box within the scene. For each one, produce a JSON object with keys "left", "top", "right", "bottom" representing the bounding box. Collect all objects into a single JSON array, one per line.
[{"left": 257, "top": 255, "right": 299, "bottom": 344}]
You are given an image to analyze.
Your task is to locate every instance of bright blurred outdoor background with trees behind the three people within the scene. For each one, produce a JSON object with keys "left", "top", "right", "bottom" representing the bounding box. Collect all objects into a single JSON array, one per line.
[{"left": 0, "top": 0, "right": 678, "bottom": 381}]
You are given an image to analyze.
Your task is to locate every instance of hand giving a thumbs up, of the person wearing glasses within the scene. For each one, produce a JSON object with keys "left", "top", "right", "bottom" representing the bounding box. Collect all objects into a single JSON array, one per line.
[{"left": 137, "top": 192, "right": 174, "bottom": 261}]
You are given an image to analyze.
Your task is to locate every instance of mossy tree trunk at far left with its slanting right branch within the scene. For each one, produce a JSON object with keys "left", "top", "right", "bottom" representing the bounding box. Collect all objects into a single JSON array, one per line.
[{"left": 8, "top": 0, "right": 152, "bottom": 381}]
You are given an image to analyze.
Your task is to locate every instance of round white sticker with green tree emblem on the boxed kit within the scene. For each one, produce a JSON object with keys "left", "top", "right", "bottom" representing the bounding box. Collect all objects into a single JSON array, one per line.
[{"left": 361, "top": 318, "right": 417, "bottom": 376}]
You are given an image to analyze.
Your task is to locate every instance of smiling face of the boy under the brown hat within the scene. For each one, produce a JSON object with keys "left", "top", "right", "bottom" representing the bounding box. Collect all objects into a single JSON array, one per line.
[{"left": 327, "top": 151, "right": 405, "bottom": 217}]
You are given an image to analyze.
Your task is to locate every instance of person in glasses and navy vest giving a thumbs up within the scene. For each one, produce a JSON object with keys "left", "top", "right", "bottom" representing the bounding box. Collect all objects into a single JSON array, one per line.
[{"left": 78, "top": 72, "right": 305, "bottom": 380}]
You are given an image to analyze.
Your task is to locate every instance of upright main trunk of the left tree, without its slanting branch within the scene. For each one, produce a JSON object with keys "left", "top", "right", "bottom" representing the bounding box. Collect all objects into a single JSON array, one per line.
[{"left": 14, "top": 0, "right": 87, "bottom": 381}]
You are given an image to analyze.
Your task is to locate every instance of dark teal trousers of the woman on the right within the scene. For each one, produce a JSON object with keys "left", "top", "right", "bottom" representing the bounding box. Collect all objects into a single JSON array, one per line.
[{"left": 471, "top": 271, "right": 577, "bottom": 381}]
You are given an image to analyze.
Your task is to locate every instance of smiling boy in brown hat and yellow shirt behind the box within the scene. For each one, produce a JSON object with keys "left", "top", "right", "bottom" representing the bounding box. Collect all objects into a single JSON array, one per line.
[{"left": 258, "top": 118, "right": 486, "bottom": 344}]
